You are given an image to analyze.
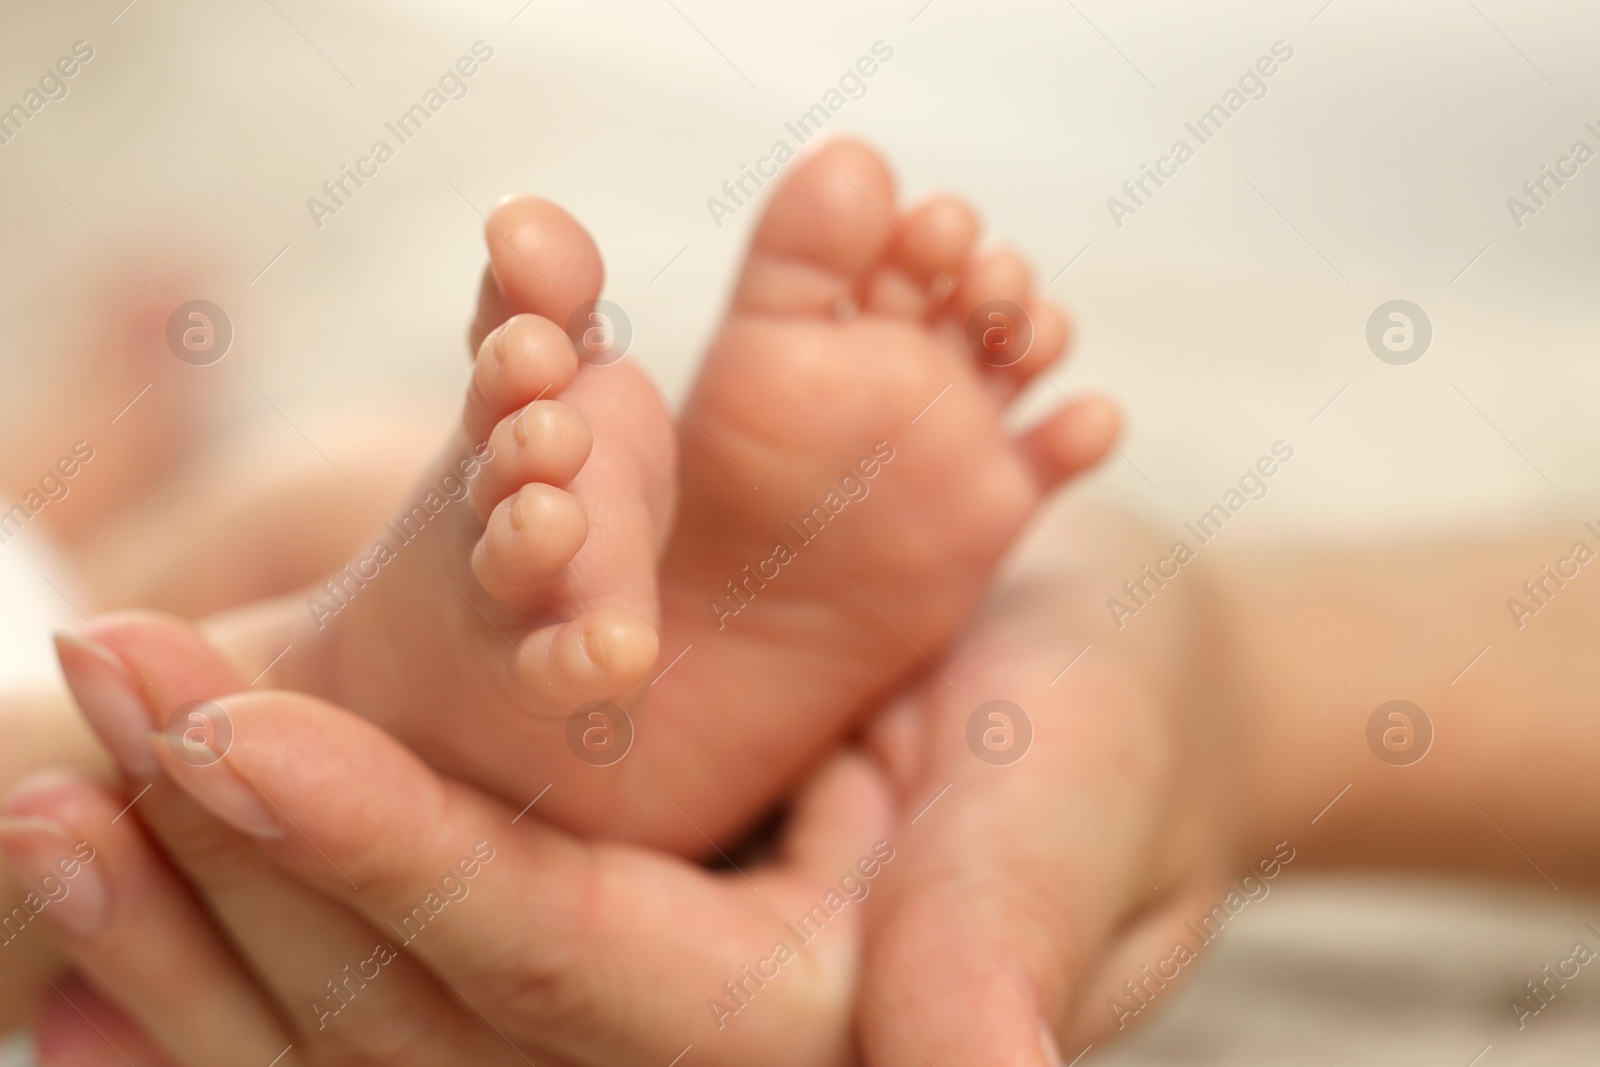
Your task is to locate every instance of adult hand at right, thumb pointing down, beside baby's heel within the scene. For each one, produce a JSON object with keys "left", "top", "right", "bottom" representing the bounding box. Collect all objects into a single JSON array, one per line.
[{"left": 859, "top": 502, "right": 1254, "bottom": 1067}]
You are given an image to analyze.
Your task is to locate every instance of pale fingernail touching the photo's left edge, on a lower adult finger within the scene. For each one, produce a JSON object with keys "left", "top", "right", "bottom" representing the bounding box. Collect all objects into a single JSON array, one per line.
[{"left": 0, "top": 816, "right": 110, "bottom": 937}]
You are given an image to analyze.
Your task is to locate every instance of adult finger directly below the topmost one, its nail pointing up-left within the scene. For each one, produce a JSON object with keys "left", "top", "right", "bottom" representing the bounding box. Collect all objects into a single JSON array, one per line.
[{"left": 58, "top": 627, "right": 509, "bottom": 1064}]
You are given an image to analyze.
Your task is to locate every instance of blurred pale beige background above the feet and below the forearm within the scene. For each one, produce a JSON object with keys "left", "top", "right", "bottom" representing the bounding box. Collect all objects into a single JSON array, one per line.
[{"left": 0, "top": 0, "right": 1600, "bottom": 1067}]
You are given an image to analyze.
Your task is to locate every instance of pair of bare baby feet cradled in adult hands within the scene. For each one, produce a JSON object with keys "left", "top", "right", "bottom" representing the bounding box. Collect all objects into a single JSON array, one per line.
[{"left": 256, "top": 141, "right": 1115, "bottom": 856}]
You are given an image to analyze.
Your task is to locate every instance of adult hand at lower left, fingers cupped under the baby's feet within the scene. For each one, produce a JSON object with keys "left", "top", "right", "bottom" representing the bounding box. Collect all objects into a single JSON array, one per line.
[{"left": 0, "top": 616, "right": 893, "bottom": 1067}]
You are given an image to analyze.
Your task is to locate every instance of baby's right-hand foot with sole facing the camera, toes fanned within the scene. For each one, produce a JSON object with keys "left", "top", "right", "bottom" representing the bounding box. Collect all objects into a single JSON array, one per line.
[{"left": 496, "top": 141, "right": 1117, "bottom": 851}]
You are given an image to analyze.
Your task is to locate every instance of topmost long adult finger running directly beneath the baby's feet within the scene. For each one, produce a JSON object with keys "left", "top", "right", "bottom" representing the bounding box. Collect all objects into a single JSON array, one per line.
[{"left": 78, "top": 607, "right": 888, "bottom": 1064}]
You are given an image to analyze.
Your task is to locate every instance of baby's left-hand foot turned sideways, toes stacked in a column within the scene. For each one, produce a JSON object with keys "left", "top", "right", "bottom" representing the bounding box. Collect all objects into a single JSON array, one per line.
[{"left": 274, "top": 200, "right": 674, "bottom": 811}]
